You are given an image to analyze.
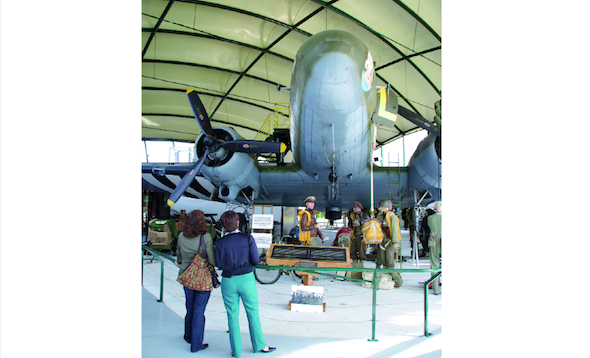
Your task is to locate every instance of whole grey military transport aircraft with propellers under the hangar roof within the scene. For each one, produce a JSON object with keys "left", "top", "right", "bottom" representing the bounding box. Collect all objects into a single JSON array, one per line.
[{"left": 142, "top": 30, "right": 441, "bottom": 220}]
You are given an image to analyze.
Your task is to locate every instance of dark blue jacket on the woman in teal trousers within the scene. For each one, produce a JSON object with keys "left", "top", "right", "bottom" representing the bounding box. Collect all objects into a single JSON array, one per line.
[{"left": 215, "top": 233, "right": 260, "bottom": 277}]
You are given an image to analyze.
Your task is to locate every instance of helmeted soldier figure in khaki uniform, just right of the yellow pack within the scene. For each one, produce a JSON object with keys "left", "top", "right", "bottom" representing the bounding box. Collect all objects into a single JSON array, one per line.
[{"left": 377, "top": 203, "right": 404, "bottom": 288}]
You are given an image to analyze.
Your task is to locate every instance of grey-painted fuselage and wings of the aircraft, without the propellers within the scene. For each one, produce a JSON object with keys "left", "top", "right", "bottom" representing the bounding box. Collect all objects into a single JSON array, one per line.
[{"left": 142, "top": 30, "right": 441, "bottom": 213}]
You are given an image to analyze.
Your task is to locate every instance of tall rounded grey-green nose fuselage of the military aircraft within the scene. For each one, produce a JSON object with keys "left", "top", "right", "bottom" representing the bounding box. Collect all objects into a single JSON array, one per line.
[{"left": 291, "top": 30, "right": 376, "bottom": 182}]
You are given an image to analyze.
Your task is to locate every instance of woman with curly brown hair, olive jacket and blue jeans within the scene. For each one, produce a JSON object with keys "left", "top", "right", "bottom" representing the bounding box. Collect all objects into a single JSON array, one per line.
[{"left": 175, "top": 210, "right": 215, "bottom": 352}]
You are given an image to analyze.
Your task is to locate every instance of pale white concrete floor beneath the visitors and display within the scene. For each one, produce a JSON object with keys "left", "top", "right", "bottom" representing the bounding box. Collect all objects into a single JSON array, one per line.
[{"left": 142, "top": 229, "right": 443, "bottom": 358}]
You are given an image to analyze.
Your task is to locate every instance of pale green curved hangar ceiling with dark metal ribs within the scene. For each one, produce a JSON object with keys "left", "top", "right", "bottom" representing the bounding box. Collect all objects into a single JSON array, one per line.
[{"left": 141, "top": 0, "right": 441, "bottom": 146}]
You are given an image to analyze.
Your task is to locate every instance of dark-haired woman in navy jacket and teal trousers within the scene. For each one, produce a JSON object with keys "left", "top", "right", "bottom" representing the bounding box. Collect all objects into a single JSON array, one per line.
[{"left": 215, "top": 210, "right": 276, "bottom": 358}]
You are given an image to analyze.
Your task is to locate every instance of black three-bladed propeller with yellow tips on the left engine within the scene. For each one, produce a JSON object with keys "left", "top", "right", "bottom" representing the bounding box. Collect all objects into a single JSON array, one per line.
[{"left": 168, "top": 88, "right": 287, "bottom": 206}]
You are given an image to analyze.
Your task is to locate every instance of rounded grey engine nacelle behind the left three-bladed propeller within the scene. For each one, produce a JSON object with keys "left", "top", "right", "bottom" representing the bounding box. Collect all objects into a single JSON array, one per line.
[{"left": 195, "top": 127, "right": 260, "bottom": 201}]
